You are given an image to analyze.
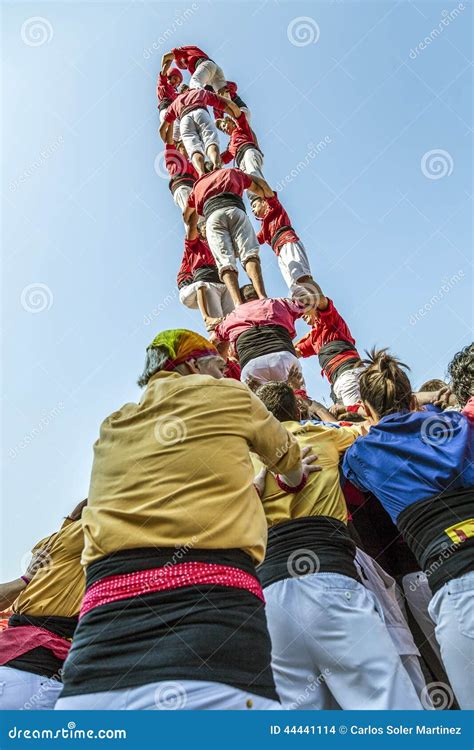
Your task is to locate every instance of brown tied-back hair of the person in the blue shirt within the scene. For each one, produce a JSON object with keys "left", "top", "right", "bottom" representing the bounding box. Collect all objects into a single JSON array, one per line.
[{"left": 359, "top": 349, "right": 412, "bottom": 417}]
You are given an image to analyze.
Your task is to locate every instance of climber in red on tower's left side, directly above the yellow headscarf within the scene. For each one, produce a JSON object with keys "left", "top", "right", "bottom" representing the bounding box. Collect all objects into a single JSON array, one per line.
[{"left": 177, "top": 213, "right": 234, "bottom": 323}]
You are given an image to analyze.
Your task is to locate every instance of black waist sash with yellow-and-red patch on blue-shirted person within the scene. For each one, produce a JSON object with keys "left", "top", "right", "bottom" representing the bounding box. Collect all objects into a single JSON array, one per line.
[{"left": 397, "top": 487, "right": 474, "bottom": 594}]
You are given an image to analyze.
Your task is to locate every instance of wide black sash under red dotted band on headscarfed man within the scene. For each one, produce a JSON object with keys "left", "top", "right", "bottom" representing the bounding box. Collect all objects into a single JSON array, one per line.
[{"left": 62, "top": 548, "right": 278, "bottom": 700}]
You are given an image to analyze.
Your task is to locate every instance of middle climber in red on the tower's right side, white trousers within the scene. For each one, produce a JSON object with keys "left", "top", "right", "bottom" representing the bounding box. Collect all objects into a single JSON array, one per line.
[{"left": 252, "top": 191, "right": 314, "bottom": 293}]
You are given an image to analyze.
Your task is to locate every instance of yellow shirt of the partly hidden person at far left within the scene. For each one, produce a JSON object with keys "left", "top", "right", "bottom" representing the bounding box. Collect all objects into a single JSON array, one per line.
[{"left": 13, "top": 519, "right": 85, "bottom": 617}]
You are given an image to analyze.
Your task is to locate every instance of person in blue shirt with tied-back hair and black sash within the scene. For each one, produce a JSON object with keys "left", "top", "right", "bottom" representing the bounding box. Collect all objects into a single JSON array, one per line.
[{"left": 343, "top": 349, "right": 474, "bottom": 709}]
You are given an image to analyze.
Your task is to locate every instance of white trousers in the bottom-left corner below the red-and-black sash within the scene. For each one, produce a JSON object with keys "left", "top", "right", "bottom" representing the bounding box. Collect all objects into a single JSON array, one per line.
[{"left": 0, "top": 667, "right": 63, "bottom": 711}]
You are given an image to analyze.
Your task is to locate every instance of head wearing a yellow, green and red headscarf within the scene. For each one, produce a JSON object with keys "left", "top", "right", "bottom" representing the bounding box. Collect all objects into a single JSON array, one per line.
[{"left": 138, "top": 328, "right": 225, "bottom": 388}]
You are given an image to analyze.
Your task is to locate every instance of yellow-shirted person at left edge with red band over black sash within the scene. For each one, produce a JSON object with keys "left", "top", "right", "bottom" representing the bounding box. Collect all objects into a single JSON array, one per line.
[{"left": 0, "top": 500, "right": 87, "bottom": 711}]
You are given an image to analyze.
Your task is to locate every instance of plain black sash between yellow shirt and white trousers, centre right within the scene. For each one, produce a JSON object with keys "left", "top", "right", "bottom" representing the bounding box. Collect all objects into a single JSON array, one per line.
[{"left": 258, "top": 516, "right": 359, "bottom": 588}]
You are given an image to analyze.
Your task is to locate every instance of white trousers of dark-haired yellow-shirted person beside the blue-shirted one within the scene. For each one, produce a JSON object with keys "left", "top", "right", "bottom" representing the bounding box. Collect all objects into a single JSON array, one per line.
[{"left": 265, "top": 573, "right": 422, "bottom": 710}]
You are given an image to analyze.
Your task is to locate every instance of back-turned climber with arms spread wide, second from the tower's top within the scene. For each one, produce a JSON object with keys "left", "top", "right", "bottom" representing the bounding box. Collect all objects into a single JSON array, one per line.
[{"left": 160, "top": 88, "right": 239, "bottom": 175}]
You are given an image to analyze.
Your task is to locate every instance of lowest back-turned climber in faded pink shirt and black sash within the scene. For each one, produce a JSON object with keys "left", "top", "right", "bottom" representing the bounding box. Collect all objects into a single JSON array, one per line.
[{"left": 210, "top": 284, "right": 305, "bottom": 388}]
